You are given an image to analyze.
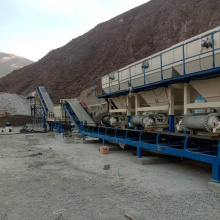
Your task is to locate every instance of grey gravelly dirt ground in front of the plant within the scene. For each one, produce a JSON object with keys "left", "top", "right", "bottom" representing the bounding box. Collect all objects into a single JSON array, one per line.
[{"left": 0, "top": 133, "right": 220, "bottom": 220}]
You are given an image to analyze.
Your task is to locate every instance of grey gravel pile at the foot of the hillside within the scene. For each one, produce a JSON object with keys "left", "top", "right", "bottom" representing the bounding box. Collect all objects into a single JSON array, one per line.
[{"left": 0, "top": 93, "right": 31, "bottom": 116}]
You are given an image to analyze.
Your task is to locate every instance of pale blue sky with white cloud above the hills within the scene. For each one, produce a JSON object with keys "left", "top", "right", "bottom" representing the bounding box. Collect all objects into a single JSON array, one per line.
[{"left": 0, "top": 0, "right": 149, "bottom": 61}]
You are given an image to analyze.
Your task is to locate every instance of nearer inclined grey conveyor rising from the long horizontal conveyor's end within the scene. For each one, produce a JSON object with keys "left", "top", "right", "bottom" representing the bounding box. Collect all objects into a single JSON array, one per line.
[{"left": 64, "top": 99, "right": 95, "bottom": 126}]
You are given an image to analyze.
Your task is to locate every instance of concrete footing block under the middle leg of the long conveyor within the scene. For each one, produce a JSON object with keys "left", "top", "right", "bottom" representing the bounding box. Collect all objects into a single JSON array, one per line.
[{"left": 134, "top": 156, "right": 176, "bottom": 165}]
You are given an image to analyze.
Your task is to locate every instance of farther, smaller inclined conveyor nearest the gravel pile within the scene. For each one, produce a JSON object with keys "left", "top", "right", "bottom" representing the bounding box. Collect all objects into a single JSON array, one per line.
[{"left": 37, "top": 86, "right": 54, "bottom": 113}]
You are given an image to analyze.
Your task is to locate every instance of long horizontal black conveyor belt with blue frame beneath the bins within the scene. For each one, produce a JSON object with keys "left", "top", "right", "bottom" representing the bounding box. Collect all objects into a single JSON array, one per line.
[{"left": 80, "top": 126, "right": 220, "bottom": 182}]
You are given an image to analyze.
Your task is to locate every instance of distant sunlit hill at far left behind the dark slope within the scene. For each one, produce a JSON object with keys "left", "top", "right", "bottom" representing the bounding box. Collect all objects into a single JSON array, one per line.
[{"left": 0, "top": 52, "right": 33, "bottom": 78}]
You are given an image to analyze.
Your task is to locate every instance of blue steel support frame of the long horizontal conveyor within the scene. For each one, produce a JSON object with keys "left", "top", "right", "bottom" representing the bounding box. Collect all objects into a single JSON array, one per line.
[{"left": 79, "top": 127, "right": 220, "bottom": 183}]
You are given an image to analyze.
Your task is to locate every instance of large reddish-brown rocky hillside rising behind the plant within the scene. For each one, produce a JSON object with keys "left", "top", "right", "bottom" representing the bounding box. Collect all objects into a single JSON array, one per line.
[{"left": 0, "top": 0, "right": 220, "bottom": 101}]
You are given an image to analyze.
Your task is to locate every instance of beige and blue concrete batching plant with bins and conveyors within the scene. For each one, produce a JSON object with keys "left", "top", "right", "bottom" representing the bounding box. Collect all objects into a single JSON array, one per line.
[{"left": 32, "top": 27, "right": 220, "bottom": 182}]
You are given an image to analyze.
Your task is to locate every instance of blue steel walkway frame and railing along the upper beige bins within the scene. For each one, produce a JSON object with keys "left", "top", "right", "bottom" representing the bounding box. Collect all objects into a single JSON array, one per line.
[{"left": 94, "top": 31, "right": 220, "bottom": 98}]
